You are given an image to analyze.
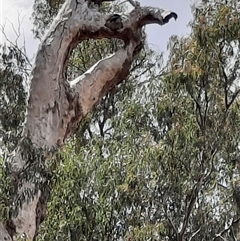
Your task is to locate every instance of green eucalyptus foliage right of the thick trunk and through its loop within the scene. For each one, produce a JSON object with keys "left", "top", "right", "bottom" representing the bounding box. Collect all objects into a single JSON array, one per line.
[{"left": 0, "top": 0, "right": 240, "bottom": 241}]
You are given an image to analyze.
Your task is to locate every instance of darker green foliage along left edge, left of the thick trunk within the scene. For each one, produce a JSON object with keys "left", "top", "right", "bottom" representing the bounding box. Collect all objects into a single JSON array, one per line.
[{"left": 0, "top": 44, "right": 30, "bottom": 220}]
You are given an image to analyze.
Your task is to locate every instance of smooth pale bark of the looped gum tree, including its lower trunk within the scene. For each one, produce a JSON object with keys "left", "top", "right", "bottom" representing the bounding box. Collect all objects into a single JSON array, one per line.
[{"left": 0, "top": 0, "right": 177, "bottom": 240}]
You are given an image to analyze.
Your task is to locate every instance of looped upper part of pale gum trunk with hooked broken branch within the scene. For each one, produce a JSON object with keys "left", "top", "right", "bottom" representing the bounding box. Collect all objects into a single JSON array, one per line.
[{"left": 26, "top": 0, "right": 177, "bottom": 146}]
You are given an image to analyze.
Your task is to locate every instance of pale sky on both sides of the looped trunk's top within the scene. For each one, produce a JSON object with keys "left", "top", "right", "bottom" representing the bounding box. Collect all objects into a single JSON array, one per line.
[{"left": 0, "top": 0, "right": 194, "bottom": 59}]
